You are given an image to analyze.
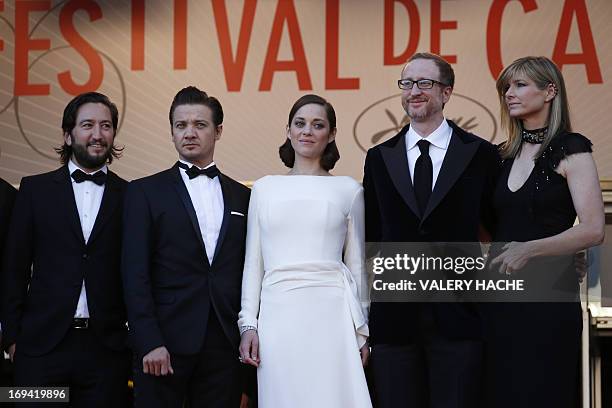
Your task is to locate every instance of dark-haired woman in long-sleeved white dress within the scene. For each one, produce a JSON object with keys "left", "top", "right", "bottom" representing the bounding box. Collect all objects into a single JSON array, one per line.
[{"left": 238, "top": 95, "right": 372, "bottom": 408}]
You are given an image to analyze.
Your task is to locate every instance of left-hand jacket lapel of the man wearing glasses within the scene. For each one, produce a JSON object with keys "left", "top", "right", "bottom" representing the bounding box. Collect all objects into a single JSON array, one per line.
[{"left": 380, "top": 126, "right": 420, "bottom": 217}]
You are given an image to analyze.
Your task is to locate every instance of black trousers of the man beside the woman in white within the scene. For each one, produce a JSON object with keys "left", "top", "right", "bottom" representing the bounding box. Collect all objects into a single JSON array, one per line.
[{"left": 134, "top": 311, "right": 242, "bottom": 408}]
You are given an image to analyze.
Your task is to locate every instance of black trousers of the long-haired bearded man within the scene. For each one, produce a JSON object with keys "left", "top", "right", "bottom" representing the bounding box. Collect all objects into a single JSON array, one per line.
[{"left": 15, "top": 329, "right": 131, "bottom": 408}]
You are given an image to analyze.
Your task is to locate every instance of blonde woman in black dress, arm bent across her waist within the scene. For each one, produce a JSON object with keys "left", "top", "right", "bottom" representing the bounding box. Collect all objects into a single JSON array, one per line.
[{"left": 484, "top": 57, "right": 604, "bottom": 408}]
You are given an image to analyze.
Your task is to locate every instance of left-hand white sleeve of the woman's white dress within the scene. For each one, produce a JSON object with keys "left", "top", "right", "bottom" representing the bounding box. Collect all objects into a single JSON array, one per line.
[{"left": 238, "top": 184, "right": 264, "bottom": 328}]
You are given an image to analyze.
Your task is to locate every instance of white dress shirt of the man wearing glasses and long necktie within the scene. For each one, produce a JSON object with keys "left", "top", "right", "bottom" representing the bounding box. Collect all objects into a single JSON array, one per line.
[{"left": 405, "top": 119, "right": 453, "bottom": 190}]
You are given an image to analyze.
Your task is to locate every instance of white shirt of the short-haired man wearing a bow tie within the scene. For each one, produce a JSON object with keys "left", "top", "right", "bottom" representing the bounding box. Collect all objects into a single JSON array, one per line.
[{"left": 179, "top": 160, "right": 223, "bottom": 264}]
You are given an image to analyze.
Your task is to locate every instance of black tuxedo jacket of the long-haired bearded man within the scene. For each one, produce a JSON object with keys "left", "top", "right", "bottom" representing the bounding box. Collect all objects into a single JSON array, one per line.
[{"left": 2, "top": 166, "right": 127, "bottom": 355}]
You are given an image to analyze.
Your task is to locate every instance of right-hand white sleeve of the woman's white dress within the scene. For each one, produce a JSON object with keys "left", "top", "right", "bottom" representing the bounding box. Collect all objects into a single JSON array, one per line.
[{"left": 344, "top": 186, "right": 370, "bottom": 322}]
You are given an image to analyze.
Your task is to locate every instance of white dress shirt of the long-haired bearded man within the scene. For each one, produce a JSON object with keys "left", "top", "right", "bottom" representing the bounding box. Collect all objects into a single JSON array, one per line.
[{"left": 68, "top": 160, "right": 108, "bottom": 318}]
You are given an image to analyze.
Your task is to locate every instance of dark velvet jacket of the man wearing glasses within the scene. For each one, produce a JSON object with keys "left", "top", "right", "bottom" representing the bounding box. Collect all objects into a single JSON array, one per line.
[{"left": 363, "top": 121, "right": 499, "bottom": 344}]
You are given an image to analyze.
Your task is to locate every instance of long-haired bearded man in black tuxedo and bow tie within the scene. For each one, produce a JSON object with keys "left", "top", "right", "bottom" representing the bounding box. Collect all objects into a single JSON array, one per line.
[{"left": 2, "top": 92, "right": 130, "bottom": 407}]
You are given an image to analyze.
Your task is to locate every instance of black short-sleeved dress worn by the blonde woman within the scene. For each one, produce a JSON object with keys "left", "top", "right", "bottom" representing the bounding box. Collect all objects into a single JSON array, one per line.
[{"left": 483, "top": 133, "right": 592, "bottom": 408}]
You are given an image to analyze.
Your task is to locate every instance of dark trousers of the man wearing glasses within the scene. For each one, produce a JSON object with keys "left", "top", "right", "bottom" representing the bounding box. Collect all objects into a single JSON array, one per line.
[{"left": 370, "top": 305, "right": 483, "bottom": 408}]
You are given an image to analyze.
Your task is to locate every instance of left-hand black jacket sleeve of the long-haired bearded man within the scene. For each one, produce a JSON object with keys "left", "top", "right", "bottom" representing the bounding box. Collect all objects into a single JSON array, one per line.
[{"left": 2, "top": 178, "right": 34, "bottom": 348}]
